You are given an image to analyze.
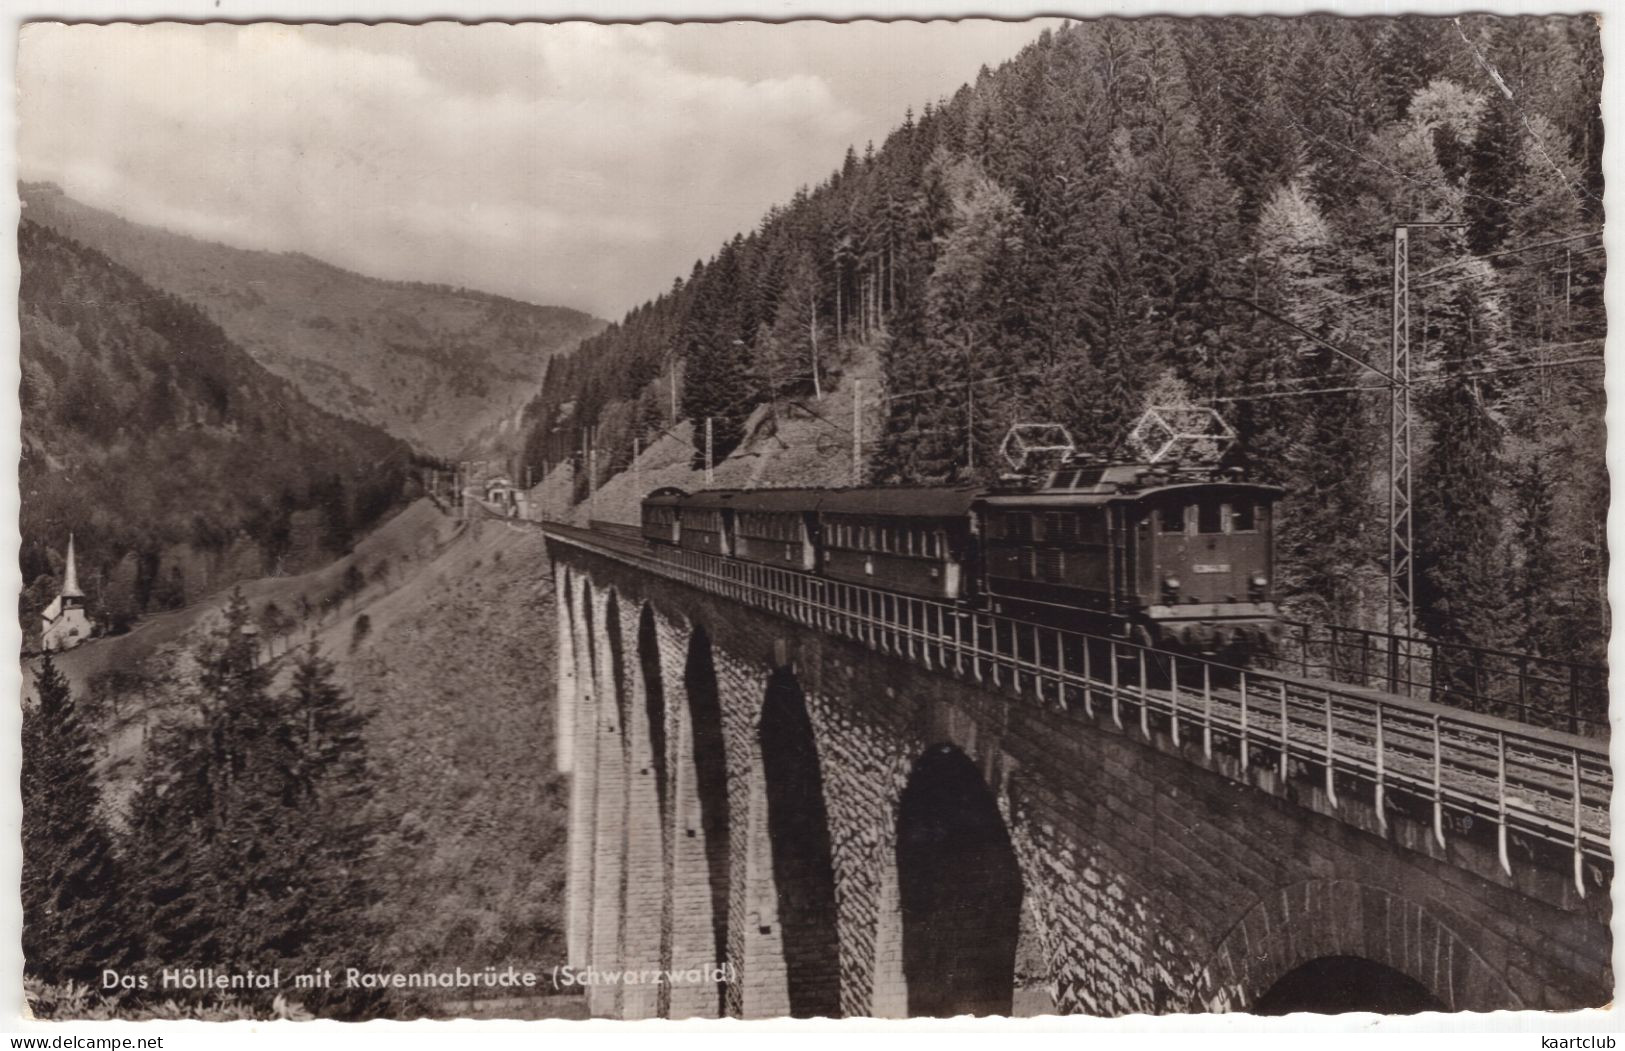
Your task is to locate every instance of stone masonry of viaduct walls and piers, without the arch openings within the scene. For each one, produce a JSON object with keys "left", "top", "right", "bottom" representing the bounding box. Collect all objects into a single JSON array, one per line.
[{"left": 553, "top": 543, "right": 1612, "bottom": 1017}]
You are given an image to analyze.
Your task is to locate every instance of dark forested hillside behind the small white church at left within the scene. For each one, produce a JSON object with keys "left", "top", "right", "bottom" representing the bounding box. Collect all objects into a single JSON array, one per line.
[{"left": 18, "top": 219, "right": 416, "bottom": 640}]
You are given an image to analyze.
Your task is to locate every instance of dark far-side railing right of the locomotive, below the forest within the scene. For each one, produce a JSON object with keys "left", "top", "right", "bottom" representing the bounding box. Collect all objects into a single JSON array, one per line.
[{"left": 1279, "top": 621, "right": 1609, "bottom": 737}]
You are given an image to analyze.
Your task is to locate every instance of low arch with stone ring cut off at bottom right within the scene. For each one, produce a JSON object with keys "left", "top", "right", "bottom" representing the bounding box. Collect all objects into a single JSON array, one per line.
[{"left": 1193, "top": 879, "right": 1523, "bottom": 1014}]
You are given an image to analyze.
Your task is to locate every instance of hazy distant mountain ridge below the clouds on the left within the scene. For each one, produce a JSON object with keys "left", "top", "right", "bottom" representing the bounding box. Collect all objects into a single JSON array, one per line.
[{"left": 20, "top": 184, "right": 605, "bottom": 458}]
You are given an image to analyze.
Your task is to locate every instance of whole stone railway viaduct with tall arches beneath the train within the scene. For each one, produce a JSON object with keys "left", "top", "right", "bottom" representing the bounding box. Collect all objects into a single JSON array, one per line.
[{"left": 548, "top": 526, "right": 1612, "bottom": 1019}]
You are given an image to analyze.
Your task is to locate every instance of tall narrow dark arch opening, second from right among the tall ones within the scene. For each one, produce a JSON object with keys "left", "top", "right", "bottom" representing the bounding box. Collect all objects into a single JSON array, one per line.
[{"left": 757, "top": 668, "right": 840, "bottom": 1019}]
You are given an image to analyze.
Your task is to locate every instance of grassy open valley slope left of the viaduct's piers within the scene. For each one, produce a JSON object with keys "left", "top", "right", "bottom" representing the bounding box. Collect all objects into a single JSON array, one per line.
[{"left": 41, "top": 500, "right": 583, "bottom": 1019}]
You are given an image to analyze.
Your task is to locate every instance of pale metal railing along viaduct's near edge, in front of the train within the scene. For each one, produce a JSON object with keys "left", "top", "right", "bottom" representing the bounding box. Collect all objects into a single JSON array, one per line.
[{"left": 548, "top": 525, "right": 1614, "bottom": 895}]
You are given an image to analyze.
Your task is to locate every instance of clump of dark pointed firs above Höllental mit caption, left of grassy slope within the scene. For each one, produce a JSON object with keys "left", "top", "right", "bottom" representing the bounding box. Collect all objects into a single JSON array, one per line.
[{"left": 132, "top": 591, "right": 380, "bottom": 1017}]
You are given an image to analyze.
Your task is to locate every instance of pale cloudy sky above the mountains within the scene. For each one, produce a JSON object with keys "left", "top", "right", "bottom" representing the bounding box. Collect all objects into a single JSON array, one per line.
[{"left": 18, "top": 21, "right": 1059, "bottom": 317}]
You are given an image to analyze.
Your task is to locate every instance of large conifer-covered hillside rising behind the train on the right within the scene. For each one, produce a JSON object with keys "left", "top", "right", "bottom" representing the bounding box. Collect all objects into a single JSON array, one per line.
[{"left": 527, "top": 16, "right": 1609, "bottom": 660}]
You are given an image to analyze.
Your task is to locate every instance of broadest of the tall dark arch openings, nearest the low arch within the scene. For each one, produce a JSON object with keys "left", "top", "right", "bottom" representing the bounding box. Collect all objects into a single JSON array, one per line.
[{"left": 897, "top": 744, "right": 1022, "bottom": 1017}]
